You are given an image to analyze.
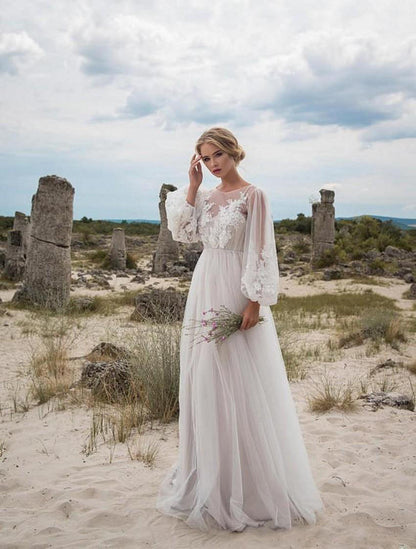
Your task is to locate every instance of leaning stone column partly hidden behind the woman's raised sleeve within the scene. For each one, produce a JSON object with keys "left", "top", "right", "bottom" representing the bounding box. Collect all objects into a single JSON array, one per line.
[{"left": 152, "top": 184, "right": 179, "bottom": 273}]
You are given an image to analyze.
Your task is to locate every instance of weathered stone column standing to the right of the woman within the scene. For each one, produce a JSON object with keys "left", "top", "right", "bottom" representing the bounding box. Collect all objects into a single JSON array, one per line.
[{"left": 312, "top": 189, "right": 335, "bottom": 265}]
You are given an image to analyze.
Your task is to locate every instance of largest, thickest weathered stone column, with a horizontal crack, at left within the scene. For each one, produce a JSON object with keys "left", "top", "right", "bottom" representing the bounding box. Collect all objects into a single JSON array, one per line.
[{"left": 13, "top": 175, "right": 75, "bottom": 309}]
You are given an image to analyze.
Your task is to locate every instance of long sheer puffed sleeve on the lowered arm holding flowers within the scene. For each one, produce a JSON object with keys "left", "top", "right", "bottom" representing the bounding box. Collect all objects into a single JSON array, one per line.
[{"left": 241, "top": 187, "right": 279, "bottom": 305}]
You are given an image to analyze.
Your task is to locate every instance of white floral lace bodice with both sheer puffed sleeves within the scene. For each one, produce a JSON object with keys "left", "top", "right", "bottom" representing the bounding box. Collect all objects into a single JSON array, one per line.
[{"left": 166, "top": 185, "right": 279, "bottom": 305}]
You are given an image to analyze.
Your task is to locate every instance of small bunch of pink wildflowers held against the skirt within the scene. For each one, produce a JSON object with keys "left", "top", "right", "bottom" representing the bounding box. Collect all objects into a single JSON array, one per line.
[{"left": 184, "top": 305, "right": 264, "bottom": 343}]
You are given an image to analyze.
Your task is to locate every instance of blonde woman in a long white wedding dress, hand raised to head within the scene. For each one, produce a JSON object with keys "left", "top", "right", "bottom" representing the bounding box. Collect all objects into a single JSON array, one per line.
[{"left": 156, "top": 128, "right": 323, "bottom": 531}]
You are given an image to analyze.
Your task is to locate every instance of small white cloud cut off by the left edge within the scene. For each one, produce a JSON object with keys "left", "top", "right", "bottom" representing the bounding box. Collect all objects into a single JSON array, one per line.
[{"left": 0, "top": 31, "right": 43, "bottom": 75}]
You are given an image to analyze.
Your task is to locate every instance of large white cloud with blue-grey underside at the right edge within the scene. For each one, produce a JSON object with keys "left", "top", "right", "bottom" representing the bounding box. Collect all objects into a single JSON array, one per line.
[{"left": 255, "top": 33, "right": 416, "bottom": 128}]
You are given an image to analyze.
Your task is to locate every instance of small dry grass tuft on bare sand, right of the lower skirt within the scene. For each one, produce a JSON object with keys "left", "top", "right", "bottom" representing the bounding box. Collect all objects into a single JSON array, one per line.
[{"left": 307, "top": 374, "right": 357, "bottom": 413}]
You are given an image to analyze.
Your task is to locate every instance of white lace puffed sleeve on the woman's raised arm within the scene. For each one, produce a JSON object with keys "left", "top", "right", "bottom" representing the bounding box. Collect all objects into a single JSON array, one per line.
[{"left": 165, "top": 186, "right": 202, "bottom": 243}]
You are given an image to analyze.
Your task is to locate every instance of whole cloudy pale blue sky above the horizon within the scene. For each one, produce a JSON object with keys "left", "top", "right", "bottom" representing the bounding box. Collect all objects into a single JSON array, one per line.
[{"left": 0, "top": 0, "right": 416, "bottom": 219}]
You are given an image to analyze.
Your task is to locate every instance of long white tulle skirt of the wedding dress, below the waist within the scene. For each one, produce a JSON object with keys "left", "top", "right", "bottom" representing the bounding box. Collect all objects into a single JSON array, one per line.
[{"left": 156, "top": 248, "right": 323, "bottom": 531}]
